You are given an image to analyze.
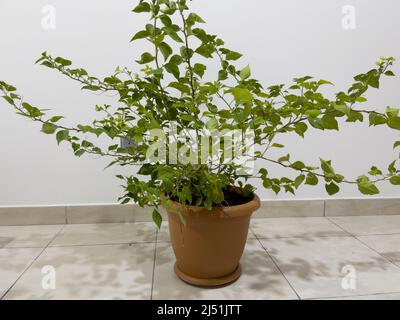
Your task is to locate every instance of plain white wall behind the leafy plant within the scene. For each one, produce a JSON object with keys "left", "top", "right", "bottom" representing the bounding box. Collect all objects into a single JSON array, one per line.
[{"left": 0, "top": 0, "right": 400, "bottom": 205}]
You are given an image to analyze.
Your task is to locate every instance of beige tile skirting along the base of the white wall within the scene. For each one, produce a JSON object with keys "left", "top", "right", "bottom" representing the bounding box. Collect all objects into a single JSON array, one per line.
[{"left": 0, "top": 198, "right": 400, "bottom": 226}]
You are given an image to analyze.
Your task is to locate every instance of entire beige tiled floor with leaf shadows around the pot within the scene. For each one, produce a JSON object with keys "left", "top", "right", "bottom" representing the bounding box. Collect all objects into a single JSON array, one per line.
[{"left": 0, "top": 216, "right": 400, "bottom": 299}]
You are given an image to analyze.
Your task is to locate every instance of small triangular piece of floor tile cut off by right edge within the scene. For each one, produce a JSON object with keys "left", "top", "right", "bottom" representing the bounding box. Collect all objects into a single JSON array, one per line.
[{"left": 357, "top": 234, "right": 400, "bottom": 263}]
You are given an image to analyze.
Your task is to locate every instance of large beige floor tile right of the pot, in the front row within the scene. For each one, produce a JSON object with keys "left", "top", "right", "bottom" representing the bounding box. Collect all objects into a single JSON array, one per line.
[{"left": 261, "top": 237, "right": 400, "bottom": 299}]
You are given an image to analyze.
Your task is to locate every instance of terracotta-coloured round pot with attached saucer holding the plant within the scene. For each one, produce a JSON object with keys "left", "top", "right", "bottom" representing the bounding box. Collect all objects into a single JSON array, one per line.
[{"left": 164, "top": 195, "right": 260, "bottom": 287}]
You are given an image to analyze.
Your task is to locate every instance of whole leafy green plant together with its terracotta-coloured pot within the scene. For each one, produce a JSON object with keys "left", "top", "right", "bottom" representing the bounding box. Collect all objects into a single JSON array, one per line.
[{"left": 0, "top": 0, "right": 400, "bottom": 286}]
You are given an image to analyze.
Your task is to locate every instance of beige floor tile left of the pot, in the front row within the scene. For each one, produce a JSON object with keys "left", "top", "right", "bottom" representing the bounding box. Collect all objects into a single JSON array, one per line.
[{"left": 5, "top": 243, "right": 155, "bottom": 300}]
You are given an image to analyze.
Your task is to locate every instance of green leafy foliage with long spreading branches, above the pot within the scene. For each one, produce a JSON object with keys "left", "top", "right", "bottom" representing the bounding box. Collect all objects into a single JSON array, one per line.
[{"left": 0, "top": 0, "right": 400, "bottom": 226}]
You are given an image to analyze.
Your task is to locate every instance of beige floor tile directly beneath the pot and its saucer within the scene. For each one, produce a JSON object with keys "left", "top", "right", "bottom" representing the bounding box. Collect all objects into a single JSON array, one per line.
[{"left": 153, "top": 240, "right": 297, "bottom": 300}]
